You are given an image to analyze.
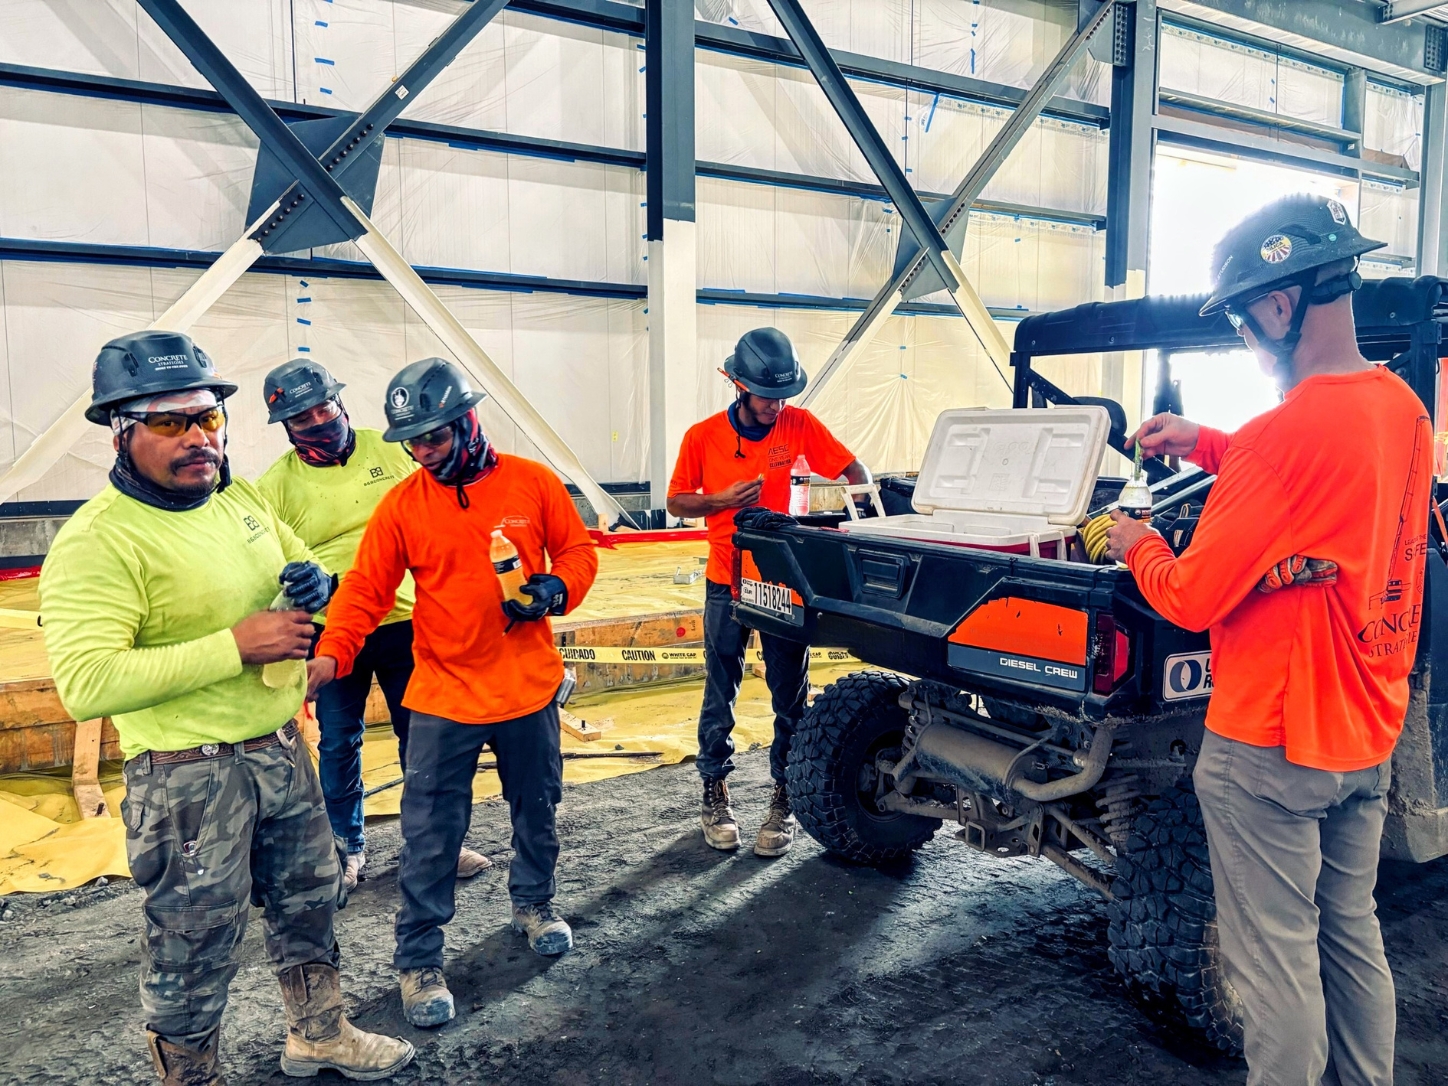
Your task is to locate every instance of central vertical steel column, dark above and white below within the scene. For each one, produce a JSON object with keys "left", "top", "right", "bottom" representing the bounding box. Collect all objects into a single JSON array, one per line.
[{"left": 644, "top": 0, "right": 698, "bottom": 517}]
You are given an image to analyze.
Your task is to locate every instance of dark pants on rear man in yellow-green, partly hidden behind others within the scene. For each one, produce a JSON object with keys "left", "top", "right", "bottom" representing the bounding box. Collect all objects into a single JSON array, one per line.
[{"left": 317, "top": 621, "right": 413, "bottom": 853}]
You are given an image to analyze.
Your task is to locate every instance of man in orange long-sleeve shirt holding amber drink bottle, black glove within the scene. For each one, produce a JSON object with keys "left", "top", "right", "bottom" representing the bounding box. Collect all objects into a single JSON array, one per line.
[{"left": 308, "top": 358, "right": 598, "bottom": 1027}]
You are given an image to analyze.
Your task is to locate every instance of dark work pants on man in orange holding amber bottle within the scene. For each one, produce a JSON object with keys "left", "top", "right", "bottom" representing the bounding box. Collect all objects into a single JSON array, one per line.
[{"left": 392, "top": 702, "right": 563, "bottom": 969}]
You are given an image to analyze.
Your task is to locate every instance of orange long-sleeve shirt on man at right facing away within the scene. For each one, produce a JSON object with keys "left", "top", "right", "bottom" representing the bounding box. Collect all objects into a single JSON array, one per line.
[{"left": 1127, "top": 368, "right": 1432, "bottom": 772}]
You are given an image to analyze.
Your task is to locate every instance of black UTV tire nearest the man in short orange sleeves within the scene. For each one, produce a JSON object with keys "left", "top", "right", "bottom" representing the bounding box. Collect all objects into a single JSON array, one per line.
[{"left": 786, "top": 672, "right": 940, "bottom": 864}]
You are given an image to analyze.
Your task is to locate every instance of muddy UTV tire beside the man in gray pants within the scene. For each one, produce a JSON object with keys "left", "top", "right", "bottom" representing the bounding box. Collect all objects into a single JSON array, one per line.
[{"left": 1108, "top": 789, "right": 1242, "bottom": 1054}]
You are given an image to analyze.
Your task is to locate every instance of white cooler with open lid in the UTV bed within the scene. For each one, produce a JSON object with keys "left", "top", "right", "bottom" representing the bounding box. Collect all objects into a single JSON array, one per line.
[{"left": 840, "top": 405, "right": 1111, "bottom": 560}]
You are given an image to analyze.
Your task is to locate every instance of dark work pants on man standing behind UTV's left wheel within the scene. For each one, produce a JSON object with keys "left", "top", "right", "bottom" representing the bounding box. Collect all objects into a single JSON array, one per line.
[{"left": 698, "top": 581, "right": 809, "bottom": 783}]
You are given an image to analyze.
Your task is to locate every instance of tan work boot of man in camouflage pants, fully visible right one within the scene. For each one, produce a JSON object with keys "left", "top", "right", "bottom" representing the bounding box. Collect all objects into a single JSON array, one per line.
[{"left": 279, "top": 961, "right": 414, "bottom": 1082}]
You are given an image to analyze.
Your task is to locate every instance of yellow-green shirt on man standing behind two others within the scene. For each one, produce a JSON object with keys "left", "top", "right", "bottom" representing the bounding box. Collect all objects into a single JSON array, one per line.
[{"left": 256, "top": 427, "right": 417, "bottom": 626}]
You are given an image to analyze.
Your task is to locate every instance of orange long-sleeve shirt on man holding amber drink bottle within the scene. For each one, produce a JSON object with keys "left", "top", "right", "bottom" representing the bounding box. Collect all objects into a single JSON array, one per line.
[{"left": 317, "top": 456, "right": 598, "bottom": 724}]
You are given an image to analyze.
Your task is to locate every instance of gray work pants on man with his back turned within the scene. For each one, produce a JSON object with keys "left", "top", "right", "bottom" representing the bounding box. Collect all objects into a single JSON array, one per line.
[{"left": 1193, "top": 731, "right": 1397, "bottom": 1086}]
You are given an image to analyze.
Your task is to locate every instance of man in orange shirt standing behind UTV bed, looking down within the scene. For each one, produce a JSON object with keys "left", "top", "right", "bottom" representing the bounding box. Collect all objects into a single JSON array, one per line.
[{"left": 668, "top": 329, "right": 870, "bottom": 856}]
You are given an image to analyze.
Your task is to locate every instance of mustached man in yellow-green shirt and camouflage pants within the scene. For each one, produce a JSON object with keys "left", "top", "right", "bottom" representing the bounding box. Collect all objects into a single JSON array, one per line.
[{"left": 41, "top": 332, "right": 413, "bottom": 1086}]
